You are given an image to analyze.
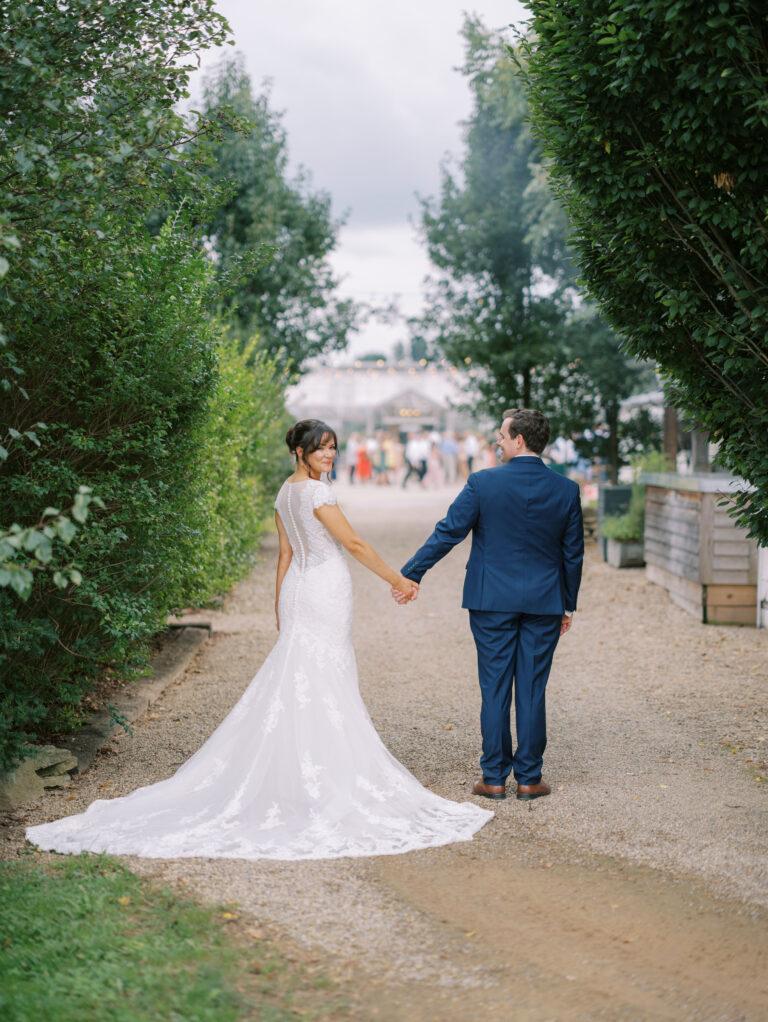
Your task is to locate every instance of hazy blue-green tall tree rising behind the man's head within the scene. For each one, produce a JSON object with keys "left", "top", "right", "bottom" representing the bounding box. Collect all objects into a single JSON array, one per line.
[{"left": 421, "top": 17, "right": 566, "bottom": 408}]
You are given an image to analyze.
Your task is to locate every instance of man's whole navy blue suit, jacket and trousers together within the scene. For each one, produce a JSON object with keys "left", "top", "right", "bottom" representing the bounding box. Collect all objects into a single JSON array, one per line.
[{"left": 402, "top": 455, "right": 584, "bottom": 785}]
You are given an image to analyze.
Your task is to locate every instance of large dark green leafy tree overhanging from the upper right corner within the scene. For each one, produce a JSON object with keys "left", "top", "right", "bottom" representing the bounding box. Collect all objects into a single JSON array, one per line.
[{"left": 522, "top": 0, "right": 768, "bottom": 543}]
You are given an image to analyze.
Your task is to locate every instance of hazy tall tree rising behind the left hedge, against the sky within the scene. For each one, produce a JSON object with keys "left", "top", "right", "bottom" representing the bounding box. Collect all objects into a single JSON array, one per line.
[{"left": 191, "top": 55, "right": 358, "bottom": 370}]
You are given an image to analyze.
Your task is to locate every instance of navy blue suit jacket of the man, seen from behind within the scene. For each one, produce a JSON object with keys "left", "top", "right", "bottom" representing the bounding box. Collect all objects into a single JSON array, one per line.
[{"left": 401, "top": 455, "right": 584, "bottom": 614}]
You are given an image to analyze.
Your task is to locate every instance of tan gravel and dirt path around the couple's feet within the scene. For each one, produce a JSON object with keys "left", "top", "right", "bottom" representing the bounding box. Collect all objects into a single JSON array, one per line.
[{"left": 10, "top": 486, "right": 768, "bottom": 1022}]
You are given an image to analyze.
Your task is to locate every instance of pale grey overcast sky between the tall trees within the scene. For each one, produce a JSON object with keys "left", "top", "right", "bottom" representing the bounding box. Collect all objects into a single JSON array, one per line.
[{"left": 192, "top": 0, "right": 527, "bottom": 354}]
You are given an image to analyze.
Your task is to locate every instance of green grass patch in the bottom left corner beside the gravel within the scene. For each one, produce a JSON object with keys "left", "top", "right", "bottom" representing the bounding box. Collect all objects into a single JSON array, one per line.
[{"left": 0, "top": 853, "right": 348, "bottom": 1022}]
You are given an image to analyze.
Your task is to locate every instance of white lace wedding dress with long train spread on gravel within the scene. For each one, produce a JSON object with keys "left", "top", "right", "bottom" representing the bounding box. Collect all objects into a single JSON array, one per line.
[{"left": 26, "top": 479, "right": 493, "bottom": 860}]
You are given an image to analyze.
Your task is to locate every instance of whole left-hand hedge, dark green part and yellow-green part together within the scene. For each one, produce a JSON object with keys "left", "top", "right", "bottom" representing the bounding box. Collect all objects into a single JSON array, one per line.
[{"left": 0, "top": 217, "right": 285, "bottom": 771}]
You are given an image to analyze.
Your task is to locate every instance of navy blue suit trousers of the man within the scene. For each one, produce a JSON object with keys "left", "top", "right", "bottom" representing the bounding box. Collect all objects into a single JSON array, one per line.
[{"left": 469, "top": 610, "right": 562, "bottom": 784}]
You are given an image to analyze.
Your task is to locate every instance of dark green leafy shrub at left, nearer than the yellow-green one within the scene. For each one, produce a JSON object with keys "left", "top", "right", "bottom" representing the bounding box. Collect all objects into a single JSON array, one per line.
[{"left": 0, "top": 224, "right": 216, "bottom": 767}]
